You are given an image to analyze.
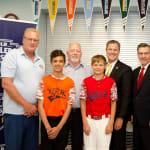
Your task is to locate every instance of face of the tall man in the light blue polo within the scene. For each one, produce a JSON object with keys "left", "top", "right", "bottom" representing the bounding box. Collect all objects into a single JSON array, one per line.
[{"left": 22, "top": 31, "right": 40, "bottom": 53}]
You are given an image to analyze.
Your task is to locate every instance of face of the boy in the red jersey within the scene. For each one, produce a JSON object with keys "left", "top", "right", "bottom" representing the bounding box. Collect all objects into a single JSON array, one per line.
[{"left": 92, "top": 60, "right": 106, "bottom": 75}]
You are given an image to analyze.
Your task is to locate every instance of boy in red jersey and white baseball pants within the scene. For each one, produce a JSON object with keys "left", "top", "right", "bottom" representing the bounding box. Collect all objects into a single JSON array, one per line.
[{"left": 80, "top": 55, "right": 117, "bottom": 150}]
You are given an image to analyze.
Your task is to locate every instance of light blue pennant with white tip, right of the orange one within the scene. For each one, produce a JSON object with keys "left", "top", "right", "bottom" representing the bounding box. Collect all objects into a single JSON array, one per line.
[{"left": 84, "top": 0, "right": 93, "bottom": 31}]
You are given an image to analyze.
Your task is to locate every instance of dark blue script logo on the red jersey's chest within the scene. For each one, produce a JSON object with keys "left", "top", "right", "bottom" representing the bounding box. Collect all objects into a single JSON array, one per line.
[{"left": 88, "top": 90, "right": 108, "bottom": 101}]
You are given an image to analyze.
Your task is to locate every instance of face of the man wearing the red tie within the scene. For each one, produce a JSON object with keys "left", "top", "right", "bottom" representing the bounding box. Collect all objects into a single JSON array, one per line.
[{"left": 138, "top": 46, "right": 150, "bottom": 67}]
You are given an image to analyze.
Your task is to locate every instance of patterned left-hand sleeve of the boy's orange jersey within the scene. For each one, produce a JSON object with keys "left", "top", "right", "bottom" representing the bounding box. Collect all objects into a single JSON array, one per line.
[{"left": 36, "top": 80, "right": 44, "bottom": 100}]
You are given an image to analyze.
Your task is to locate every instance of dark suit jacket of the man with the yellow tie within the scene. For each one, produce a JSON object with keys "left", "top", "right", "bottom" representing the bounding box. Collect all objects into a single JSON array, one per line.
[{"left": 110, "top": 60, "right": 132, "bottom": 120}]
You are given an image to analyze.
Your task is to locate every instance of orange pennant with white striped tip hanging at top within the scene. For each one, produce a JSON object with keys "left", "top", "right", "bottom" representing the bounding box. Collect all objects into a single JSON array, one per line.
[{"left": 66, "top": 0, "right": 76, "bottom": 32}]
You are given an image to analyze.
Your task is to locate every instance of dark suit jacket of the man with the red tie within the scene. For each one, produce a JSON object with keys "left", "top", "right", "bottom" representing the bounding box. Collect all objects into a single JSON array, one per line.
[{"left": 133, "top": 65, "right": 150, "bottom": 127}]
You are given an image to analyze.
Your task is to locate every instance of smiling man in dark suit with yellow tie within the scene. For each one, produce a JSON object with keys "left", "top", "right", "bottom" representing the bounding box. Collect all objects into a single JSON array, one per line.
[{"left": 106, "top": 40, "right": 132, "bottom": 150}]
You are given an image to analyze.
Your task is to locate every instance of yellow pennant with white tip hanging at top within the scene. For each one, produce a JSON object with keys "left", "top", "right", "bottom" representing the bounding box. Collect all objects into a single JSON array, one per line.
[{"left": 48, "top": 0, "right": 59, "bottom": 33}]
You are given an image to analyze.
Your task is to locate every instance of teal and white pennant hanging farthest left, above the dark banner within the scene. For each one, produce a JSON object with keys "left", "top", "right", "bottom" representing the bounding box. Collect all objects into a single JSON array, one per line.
[{"left": 32, "top": 0, "right": 42, "bottom": 23}]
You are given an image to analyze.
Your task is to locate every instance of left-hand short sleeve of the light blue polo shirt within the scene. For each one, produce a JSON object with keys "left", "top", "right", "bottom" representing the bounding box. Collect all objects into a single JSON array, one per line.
[{"left": 1, "top": 51, "right": 17, "bottom": 78}]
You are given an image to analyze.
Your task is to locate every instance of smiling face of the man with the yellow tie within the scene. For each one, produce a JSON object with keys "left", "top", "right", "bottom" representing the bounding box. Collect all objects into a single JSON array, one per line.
[{"left": 106, "top": 43, "right": 120, "bottom": 63}]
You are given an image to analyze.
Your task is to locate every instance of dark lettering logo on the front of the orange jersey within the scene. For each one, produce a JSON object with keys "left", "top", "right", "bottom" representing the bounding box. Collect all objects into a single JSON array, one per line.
[{"left": 48, "top": 88, "right": 66, "bottom": 102}]
